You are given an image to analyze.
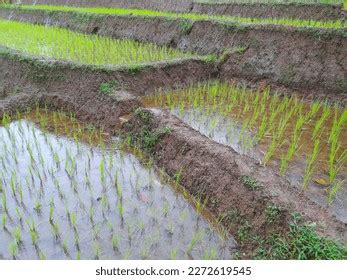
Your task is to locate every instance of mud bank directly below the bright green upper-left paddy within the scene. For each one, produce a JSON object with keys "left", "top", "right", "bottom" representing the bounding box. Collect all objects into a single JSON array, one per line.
[{"left": 0, "top": 48, "right": 213, "bottom": 129}]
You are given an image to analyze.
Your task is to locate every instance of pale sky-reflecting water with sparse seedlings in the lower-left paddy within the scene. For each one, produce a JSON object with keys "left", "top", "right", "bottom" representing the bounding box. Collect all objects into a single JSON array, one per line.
[{"left": 0, "top": 117, "right": 235, "bottom": 259}]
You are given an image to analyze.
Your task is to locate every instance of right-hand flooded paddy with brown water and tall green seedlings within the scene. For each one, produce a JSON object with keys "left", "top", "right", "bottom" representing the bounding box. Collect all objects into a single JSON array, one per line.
[{"left": 143, "top": 82, "right": 347, "bottom": 206}]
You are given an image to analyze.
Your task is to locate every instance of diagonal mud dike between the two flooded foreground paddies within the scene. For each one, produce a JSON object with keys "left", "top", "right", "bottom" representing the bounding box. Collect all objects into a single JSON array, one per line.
[{"left": 122, "top": 109, "right": 347, "bottom": 258}]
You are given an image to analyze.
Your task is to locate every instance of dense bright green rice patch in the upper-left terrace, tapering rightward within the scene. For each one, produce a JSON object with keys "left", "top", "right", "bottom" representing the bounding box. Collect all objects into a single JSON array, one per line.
[{"left": 0, "top": 20, "right": 191, "bottom": 67}]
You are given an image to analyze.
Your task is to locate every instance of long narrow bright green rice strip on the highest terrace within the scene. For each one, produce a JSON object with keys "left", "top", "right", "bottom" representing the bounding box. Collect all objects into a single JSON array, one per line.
[{"left": 2, "top": 5, "right": 346, "bottom": 28}]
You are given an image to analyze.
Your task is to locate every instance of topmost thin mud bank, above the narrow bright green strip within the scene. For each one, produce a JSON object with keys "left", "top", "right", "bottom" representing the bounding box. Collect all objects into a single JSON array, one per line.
[{"left": 21, "top": 0, "right": 344, "bottom": 20}]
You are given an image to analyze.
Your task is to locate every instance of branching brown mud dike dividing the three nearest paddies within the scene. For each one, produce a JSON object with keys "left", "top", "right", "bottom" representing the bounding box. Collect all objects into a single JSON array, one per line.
[{"left": 0, "top": 48, "right": 347, "bottom": 258}]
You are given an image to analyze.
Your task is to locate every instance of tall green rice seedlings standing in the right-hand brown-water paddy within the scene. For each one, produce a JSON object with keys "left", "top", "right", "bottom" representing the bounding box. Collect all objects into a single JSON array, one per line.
[{"left": 144, "top": 81, "right": 347, "bottom": 203}]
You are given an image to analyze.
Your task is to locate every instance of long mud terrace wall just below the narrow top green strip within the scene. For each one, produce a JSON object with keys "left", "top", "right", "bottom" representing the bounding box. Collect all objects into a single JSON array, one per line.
[{"left": 0, "top": 8, "right": 347, "bottom": 99}]
